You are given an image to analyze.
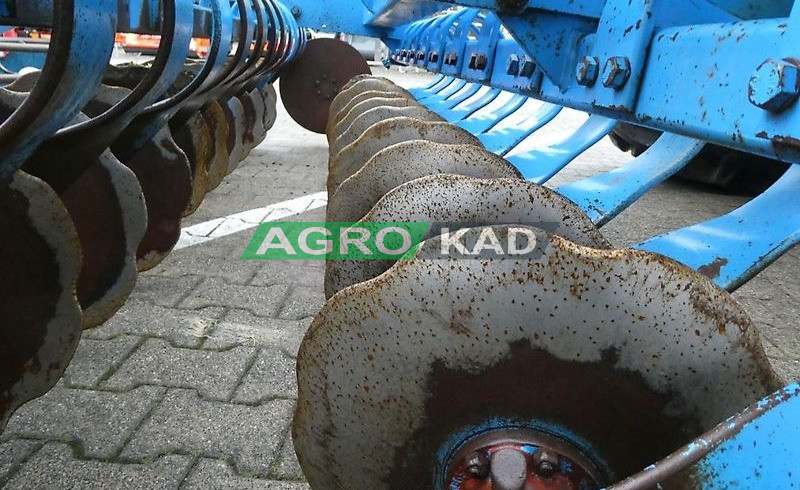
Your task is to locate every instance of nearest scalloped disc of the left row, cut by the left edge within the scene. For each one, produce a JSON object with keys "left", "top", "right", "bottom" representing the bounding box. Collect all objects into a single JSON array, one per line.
[{"left": 0, "top": 171, "right": 81, "bottom": 430}]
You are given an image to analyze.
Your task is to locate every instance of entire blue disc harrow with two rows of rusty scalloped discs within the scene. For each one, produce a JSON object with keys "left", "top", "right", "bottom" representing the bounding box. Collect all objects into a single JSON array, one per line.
[{"left": 0, "top": 0, "right": 800, "bottom": 490}]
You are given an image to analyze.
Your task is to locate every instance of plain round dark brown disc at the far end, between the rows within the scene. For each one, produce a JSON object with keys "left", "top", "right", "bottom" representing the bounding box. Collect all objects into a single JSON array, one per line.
[{"left": 280, "top": 39, "right": 370, "bottom": 133}]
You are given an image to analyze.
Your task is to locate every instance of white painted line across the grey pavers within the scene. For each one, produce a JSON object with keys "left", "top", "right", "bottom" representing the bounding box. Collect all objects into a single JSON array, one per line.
[{"left": 174, "top": 192, "right": 328, "bottom": 250}]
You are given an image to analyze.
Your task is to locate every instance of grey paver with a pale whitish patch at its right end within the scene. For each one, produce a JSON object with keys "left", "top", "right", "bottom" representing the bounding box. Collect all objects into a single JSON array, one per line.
[{"left": 83, "top": 301, "right": 225, "bottom": 347}]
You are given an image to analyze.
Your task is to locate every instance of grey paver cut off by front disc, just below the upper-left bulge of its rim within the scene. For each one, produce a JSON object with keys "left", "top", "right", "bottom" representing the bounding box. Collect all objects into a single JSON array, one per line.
[{"left": 233, "top": 349, "right": 297, "bottom": 403}]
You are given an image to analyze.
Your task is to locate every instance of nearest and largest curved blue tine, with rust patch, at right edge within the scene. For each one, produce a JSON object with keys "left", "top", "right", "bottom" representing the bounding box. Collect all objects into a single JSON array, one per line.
[{"left": 634, "top": 165, "right": 800, "bottom": 291}]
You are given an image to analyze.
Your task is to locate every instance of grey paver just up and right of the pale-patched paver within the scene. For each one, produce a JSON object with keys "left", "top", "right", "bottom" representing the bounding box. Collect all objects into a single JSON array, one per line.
[{"left": 180, "top": 277, "right": 289, "bottom": 318}]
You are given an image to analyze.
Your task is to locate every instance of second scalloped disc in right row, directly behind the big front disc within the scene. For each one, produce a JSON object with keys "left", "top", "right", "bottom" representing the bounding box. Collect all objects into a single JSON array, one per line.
[{"left": 325, "top": 174, "right": 611, "bottom": 297}]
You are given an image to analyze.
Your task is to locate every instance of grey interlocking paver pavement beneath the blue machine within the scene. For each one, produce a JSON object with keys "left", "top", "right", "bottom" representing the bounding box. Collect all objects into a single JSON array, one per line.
[{"left": 0, "top": 69, "right": 800, "bottom": 490}]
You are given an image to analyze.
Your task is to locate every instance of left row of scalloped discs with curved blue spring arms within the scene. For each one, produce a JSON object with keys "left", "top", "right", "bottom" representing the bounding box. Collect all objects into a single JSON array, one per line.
[{"left": 0, "top": 0, "right": 307, "bottom": 428}]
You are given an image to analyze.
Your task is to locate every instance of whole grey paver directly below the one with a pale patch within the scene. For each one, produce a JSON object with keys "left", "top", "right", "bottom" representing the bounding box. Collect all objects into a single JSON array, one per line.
[{"left": 103, "top": 339, "right": 256, "bottom": 400}]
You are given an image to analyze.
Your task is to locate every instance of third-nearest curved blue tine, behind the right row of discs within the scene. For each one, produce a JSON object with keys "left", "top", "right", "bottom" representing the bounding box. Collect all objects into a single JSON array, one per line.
[{"left": 507, "top": 115, "right": 617, "bottom": 184}]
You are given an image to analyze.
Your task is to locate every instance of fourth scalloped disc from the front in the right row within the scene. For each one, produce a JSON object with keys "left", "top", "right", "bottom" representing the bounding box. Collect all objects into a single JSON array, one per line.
[{"left": 327, "top": 117, "right": 481, "bottom": 198}]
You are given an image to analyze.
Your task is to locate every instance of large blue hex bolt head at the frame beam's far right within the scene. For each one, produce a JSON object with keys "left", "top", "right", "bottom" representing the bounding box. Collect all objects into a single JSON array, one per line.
[{"left": 748, "top": 59, "right": 800, "bottom": 112}]
